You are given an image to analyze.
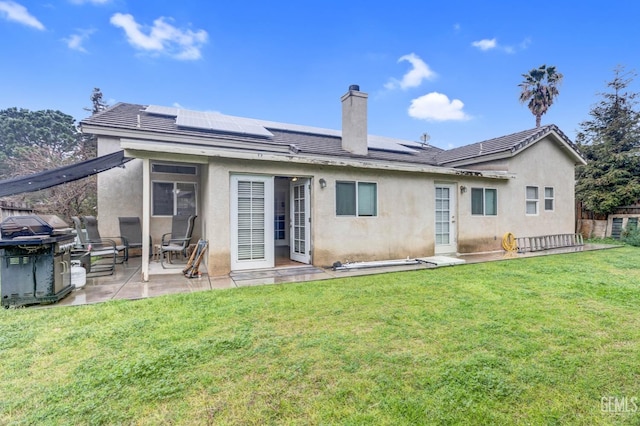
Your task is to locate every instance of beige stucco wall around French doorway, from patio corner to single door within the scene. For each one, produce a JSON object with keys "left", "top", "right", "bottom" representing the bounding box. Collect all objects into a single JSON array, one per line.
[{"left": 205, "top": 159, "right": 434, "bottom": 275}]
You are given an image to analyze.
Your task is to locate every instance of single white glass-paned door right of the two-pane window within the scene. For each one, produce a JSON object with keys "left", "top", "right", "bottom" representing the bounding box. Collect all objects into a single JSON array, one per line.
[{"left": 435, "top": 184, "right": 458, "bottom": 254}]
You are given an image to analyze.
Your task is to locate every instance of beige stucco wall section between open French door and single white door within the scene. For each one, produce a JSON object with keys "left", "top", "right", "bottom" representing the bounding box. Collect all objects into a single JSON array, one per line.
[{"left": 313, "top": 168, "right": 435, "bottom": 266}]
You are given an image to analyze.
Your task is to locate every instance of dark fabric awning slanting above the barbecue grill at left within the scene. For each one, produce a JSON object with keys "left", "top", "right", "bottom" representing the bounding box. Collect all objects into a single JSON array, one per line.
[{"left": 0, "top": 151, "right": 132, "bottom": 197}]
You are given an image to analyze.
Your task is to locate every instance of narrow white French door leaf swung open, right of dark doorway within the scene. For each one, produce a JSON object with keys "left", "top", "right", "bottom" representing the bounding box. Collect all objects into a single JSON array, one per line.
[{"left": 289, "top": 179, "right": 311, "bottom": 263}]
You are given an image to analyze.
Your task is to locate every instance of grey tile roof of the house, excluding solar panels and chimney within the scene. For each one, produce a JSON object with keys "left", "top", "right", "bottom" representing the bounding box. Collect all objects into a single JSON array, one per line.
[{"left": 80, "top": 103, "right": 574, "bottom": 167}]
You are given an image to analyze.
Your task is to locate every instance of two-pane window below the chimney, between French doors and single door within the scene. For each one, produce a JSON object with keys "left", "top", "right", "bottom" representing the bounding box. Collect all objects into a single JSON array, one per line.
[{"left": 336, "top": 182, "right": 378, "bottom": 216}]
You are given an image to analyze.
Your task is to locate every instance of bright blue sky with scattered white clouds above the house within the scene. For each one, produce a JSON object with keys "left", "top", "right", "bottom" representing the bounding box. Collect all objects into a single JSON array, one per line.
[{"left": 0, "top": 0, "right": 640, "bottom": 148}]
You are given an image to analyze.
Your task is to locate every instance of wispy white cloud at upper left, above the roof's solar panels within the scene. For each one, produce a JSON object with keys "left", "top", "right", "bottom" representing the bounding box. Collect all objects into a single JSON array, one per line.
[{"left": 111, "top": 13, "right": 208, "bottom": 60}]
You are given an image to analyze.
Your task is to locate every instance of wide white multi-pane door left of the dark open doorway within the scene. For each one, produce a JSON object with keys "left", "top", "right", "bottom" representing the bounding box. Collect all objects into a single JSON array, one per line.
[{"left": 231, "top": 175, "right": 274, "bottom": 271}]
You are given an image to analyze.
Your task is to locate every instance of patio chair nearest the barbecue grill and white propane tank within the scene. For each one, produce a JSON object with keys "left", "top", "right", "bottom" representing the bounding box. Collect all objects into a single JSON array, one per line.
[{"left": 71, "top": 216, "right": 118, "bottom": 277}]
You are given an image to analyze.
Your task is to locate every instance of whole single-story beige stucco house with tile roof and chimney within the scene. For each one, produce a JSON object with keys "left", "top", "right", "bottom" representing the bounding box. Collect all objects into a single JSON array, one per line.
[{"left": 81, "top": 86, "right": 584, "bottom": 279}]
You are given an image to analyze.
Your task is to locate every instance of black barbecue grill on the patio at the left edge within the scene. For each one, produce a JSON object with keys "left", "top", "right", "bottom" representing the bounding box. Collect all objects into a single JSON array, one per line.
[{"left": 0, "top": 215, "right": 75, "bottom": 308}]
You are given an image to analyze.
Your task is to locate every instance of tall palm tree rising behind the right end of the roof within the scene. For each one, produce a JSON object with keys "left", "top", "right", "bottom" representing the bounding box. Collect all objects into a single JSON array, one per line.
[{"left": 518, "top": 65, "right": 563, "bottom": 127}]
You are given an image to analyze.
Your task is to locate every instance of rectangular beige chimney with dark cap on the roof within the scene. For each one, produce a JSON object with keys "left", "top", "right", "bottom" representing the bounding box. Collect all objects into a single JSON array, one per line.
[{"left": 340, "top": 84, "right": 369, "bottom": 155}]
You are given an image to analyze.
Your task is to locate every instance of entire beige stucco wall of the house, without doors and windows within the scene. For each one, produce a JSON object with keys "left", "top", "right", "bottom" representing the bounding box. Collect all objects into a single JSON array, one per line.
[{"left": 98, "top": 133, "right": 575, "bottom": 275}]
